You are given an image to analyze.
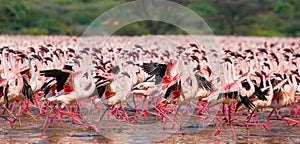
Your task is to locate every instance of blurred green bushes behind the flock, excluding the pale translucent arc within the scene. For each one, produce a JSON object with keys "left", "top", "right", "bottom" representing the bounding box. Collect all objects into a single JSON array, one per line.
[{"left": 0, "top": 0, "right": 300, "bottom": 37}]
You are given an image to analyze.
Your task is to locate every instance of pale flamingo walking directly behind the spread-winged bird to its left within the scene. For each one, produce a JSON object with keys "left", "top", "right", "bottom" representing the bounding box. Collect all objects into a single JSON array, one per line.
[{"left": 94, "top": 65, "right": 143, "bottom": 123}]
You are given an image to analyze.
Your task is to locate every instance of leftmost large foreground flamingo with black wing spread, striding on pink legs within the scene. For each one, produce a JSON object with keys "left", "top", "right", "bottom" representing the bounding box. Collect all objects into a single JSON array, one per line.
[{"left": 41, "top": 62, "right": 99, "bottom": 134}]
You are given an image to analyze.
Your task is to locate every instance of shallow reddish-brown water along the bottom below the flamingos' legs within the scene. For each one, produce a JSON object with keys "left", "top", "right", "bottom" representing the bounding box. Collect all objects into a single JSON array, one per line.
[{"left": 0, "top": 106, "right": 300, "bottom": 144}]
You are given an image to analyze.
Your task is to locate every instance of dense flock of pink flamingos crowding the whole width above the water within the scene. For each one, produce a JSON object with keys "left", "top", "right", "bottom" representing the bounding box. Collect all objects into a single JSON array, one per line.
[{"left": 0, "top": 35, "right": 300, "bottom": 137}]
